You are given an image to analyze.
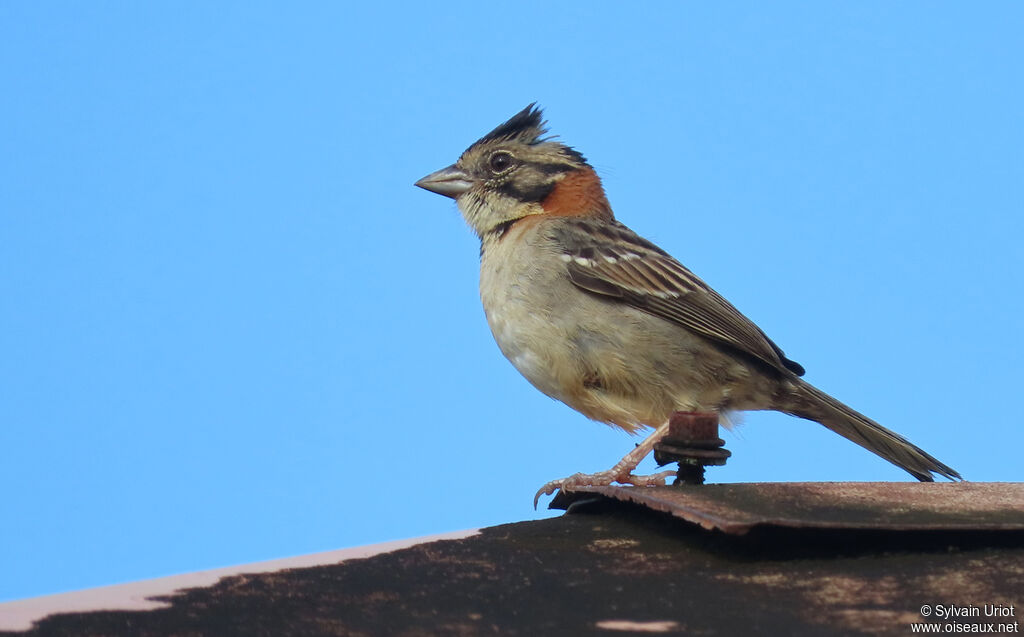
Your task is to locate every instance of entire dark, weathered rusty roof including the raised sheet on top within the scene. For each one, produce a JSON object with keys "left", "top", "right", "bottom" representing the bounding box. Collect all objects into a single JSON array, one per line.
[{"left": 0, "top": 483, "right": 1024, "bottom": 637}]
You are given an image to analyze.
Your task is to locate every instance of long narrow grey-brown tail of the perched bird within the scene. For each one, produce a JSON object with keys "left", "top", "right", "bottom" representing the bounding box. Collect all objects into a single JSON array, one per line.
[{"left": 779, "top": 381, "right": 962, "bottom": 482}]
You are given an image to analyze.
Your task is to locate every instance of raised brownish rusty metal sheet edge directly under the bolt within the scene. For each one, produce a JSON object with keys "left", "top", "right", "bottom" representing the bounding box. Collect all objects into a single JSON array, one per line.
[{"left": 551, "top": 482, "right": 1024, "bottom": 535}]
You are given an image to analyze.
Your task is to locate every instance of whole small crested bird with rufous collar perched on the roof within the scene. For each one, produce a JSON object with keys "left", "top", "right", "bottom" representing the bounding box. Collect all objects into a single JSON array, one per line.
[{"left": 416, "top": 102, "right": 962, "bottom": 506}]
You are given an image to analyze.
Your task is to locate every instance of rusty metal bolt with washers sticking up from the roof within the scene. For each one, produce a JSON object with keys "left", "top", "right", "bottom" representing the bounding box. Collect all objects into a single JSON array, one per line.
[{"left": 654, "top": 412, "right": 732, "bottom": 484}]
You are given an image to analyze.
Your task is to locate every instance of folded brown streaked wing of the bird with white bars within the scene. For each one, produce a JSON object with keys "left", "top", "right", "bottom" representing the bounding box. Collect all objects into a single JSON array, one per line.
[{"left": 554, "top": 218, "right": 804, "bottom": 376}]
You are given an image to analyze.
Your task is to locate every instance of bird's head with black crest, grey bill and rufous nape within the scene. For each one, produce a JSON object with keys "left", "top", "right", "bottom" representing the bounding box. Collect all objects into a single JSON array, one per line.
[{"left": 416, "top": 104, "right": 612, "bottom": 238}]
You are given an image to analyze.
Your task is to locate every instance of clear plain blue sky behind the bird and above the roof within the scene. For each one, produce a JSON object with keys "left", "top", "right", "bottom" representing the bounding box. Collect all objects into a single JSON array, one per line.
[{"left": 0, "top": 2, "right": 1024, "bottom": 599}]
